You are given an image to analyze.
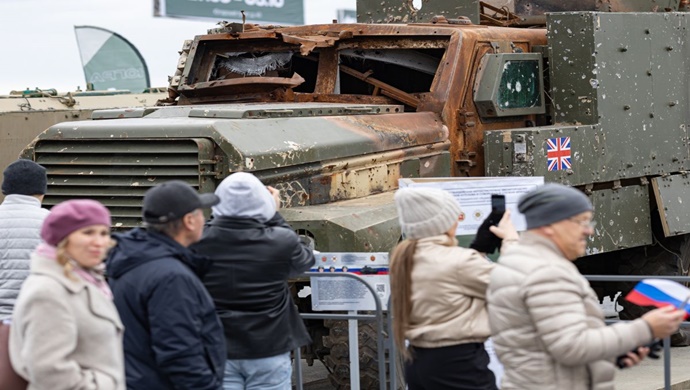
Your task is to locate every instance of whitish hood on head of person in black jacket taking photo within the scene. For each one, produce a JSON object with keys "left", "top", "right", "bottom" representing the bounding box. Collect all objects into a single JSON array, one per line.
[{"left": 213, "top": 172, "right": 276, "bottom": 222}]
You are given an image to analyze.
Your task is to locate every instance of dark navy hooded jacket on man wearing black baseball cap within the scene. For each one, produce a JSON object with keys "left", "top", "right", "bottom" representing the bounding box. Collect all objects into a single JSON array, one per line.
[{"left": 106, "top": 228, "right": 225, "bottom": 390}]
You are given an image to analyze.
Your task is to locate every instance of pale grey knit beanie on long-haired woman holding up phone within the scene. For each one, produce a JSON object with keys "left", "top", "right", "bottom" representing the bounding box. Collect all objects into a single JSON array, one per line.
[{"left": 394, "top": 187, "right": 461, "bottom": 240}]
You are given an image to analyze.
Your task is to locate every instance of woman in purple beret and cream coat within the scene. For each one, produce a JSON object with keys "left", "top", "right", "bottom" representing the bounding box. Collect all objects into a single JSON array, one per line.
[{"left": 9, "top": 199, "right": 126, "bottom": 390}]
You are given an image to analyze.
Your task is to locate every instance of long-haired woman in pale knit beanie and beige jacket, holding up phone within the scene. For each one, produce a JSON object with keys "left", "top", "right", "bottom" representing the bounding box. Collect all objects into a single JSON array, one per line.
[{"left": 390, "top": 187, "right": 517, "bottom": 390}]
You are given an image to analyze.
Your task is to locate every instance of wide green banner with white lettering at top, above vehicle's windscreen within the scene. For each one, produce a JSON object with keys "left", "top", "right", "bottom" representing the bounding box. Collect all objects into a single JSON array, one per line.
[{"left": 161, "top": 0, "right": 304, "bottom": 25}]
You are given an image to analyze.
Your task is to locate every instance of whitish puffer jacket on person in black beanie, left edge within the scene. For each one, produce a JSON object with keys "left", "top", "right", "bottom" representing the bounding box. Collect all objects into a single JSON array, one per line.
[{"left": 0, "top": 195, "right": 50, "bottom": 321}]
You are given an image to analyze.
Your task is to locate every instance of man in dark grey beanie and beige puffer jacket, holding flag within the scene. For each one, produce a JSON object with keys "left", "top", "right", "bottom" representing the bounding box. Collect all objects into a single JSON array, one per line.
[{"left": 487, "top": 184, "right": 685, "bottom": 390}]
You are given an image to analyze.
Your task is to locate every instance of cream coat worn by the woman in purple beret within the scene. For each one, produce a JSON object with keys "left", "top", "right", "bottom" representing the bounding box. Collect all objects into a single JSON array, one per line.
[{"left": 9, "top": 254, "right": 126, "bottom": 390}]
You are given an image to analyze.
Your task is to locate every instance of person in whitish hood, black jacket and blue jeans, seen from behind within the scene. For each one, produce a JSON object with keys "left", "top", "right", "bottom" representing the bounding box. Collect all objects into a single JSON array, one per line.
[{"left": 192, "top": 172, "right": 315, "bottom": 390}]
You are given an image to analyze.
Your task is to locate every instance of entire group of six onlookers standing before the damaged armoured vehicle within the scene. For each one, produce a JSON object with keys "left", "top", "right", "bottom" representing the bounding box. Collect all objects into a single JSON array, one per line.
[{"left": 0, "top": 156, "right": 686, "bottom": 390}]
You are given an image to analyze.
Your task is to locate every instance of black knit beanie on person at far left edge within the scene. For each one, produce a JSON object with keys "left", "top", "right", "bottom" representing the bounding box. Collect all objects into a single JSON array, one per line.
[{"left": 2, "top": 159, "right": 48, "bottom": 195}]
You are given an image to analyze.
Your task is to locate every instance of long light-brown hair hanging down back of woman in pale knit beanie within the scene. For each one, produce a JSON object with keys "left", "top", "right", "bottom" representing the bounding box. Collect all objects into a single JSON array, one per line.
[{"left": 390, "top": 240, "right": 417, "bottom": 361}]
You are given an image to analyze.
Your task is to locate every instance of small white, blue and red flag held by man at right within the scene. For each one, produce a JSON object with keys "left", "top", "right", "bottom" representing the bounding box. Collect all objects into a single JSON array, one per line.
[{"left": 625, "top": 279, "right": 690, "bottom": 313}]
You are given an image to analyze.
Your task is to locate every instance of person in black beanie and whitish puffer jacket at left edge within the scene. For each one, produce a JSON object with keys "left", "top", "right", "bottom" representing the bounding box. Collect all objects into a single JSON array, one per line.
[{"left": 0, "top": 160, "right": 49, "bottom": 321}]
